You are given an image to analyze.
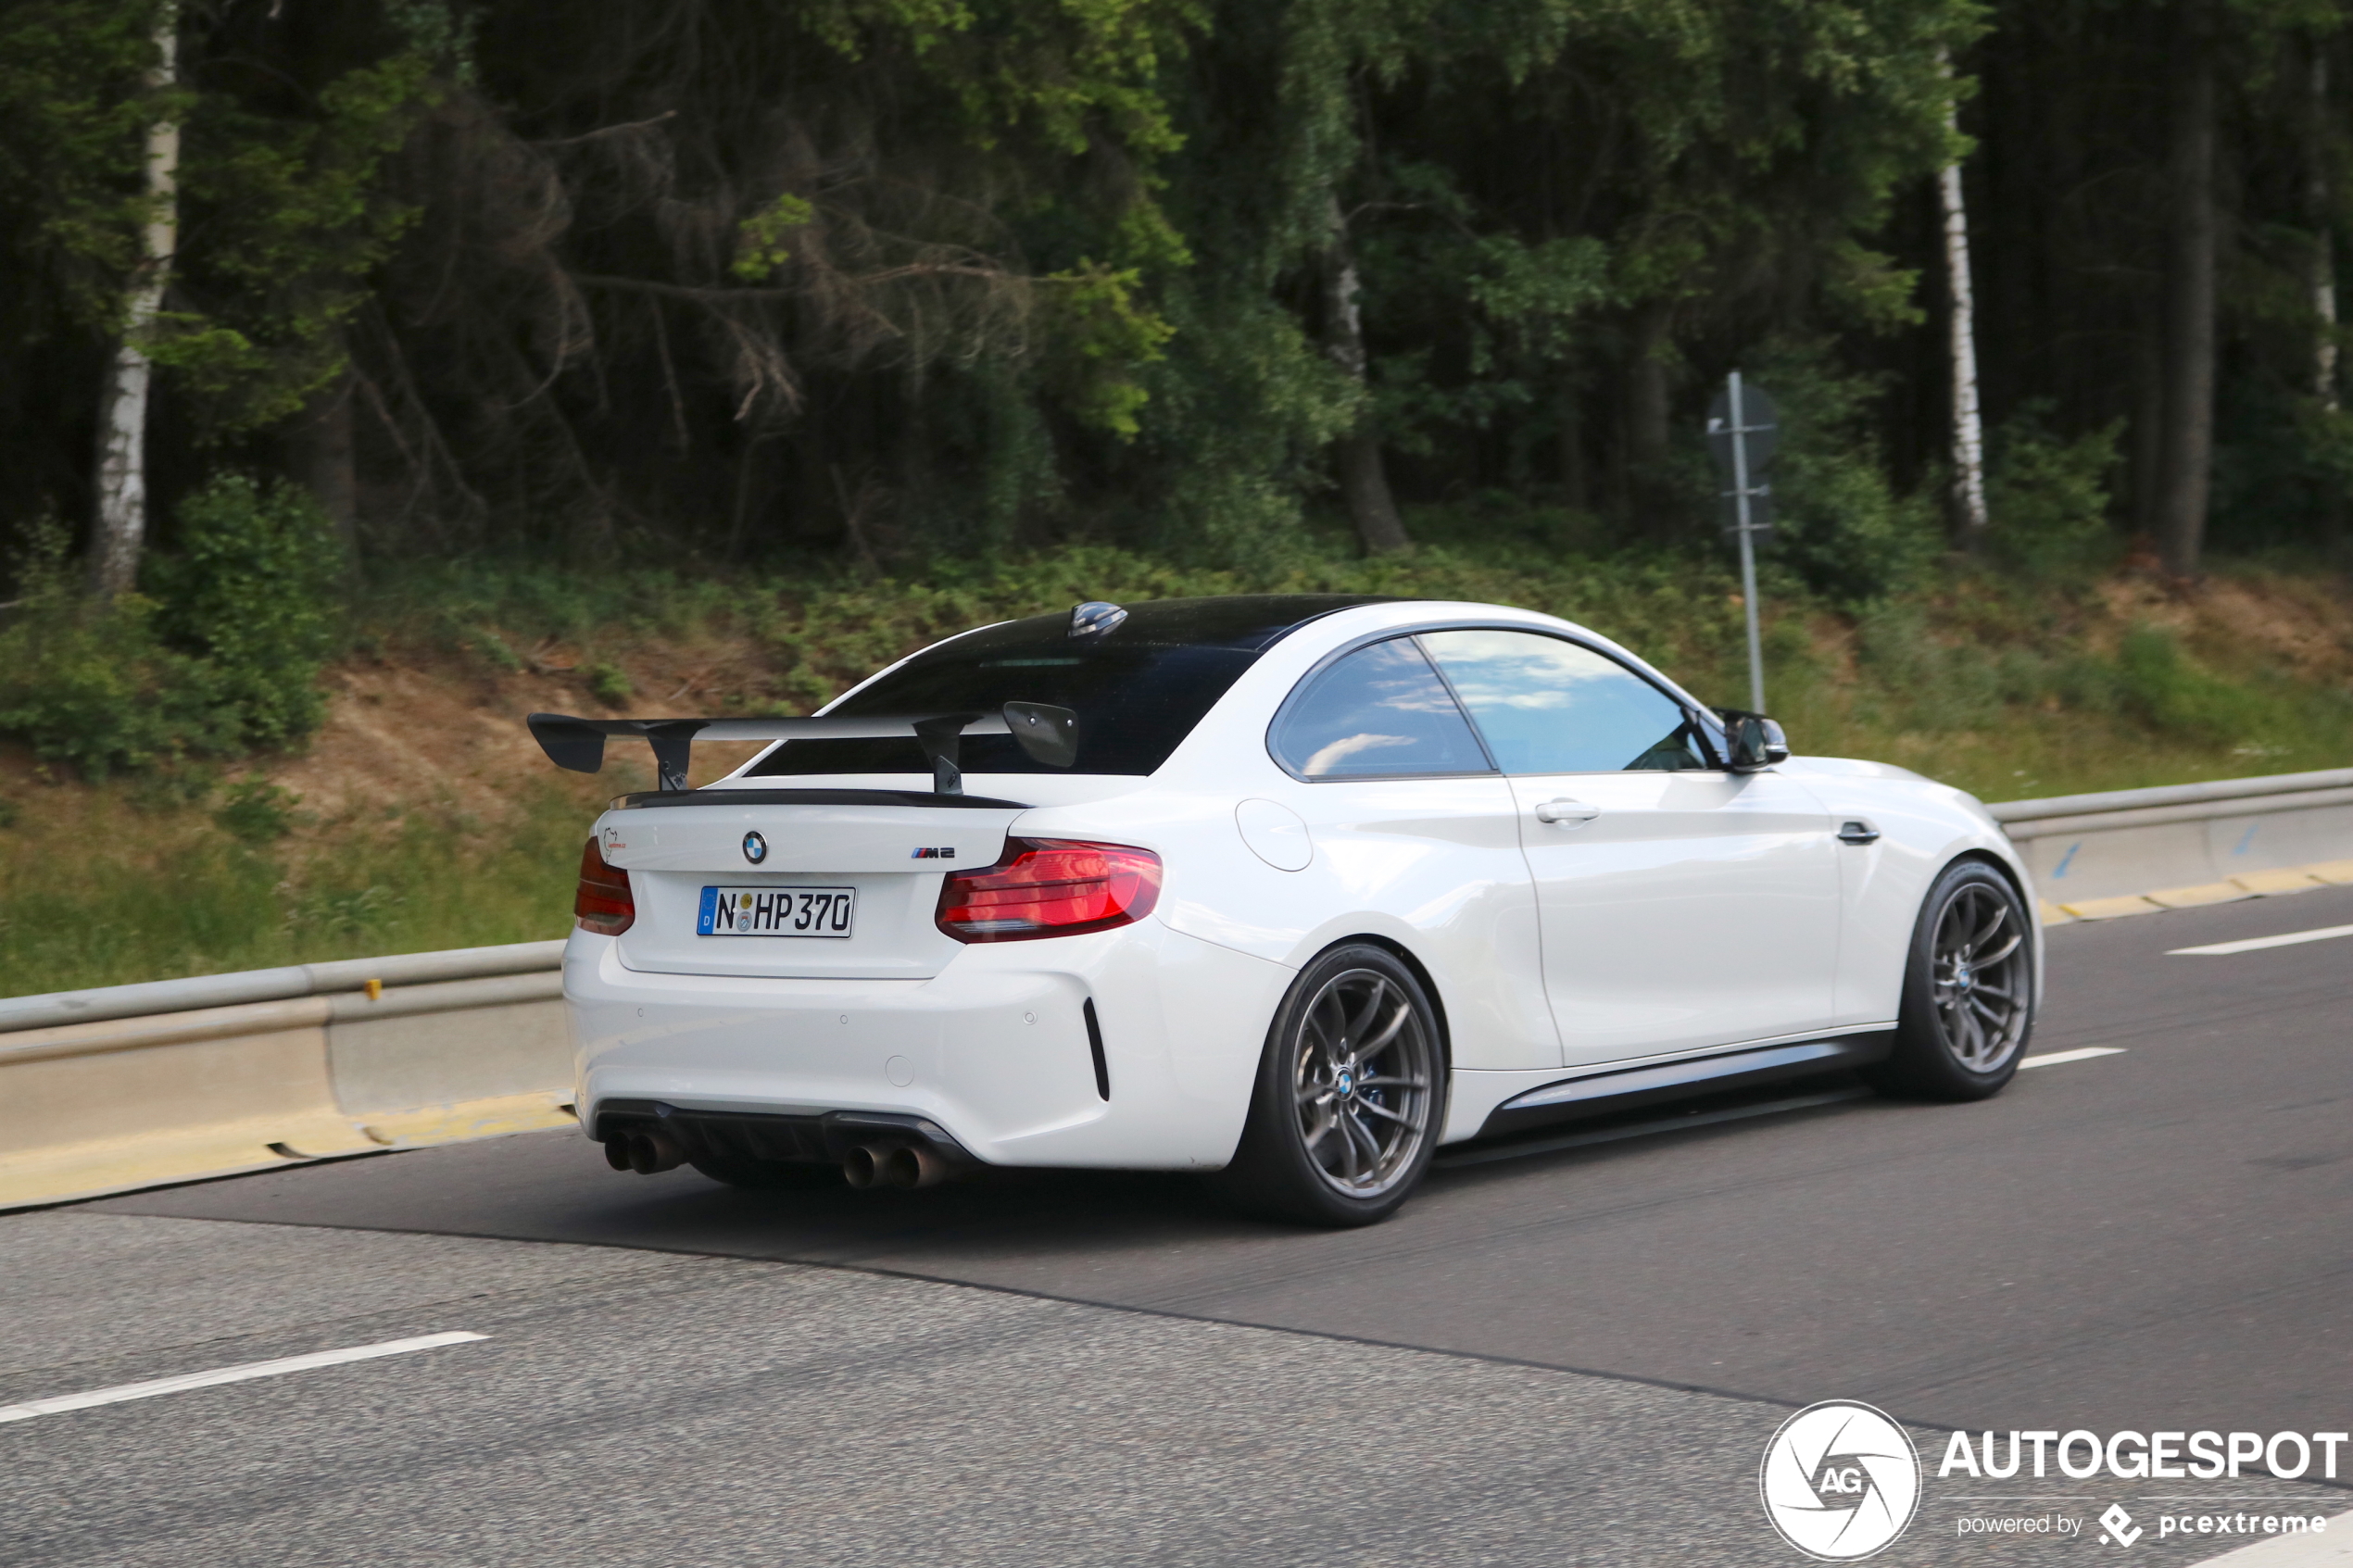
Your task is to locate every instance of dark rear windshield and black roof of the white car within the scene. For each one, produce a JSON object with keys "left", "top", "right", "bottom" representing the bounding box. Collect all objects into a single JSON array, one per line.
[{"left": 750, "top": 595, "right": 1377, "bottom": 778}]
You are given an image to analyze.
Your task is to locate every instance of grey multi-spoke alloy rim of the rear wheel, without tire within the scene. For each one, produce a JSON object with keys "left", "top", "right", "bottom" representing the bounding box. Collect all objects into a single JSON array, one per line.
[{"left": 1294, "top": 969, "right": 1438, "bottom": 1198}]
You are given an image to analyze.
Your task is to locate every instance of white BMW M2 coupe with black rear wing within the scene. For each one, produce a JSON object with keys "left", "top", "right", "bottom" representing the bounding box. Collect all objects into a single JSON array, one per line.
[{"left": 532, "top": 597, "right": 2043, "bottom": 1224}]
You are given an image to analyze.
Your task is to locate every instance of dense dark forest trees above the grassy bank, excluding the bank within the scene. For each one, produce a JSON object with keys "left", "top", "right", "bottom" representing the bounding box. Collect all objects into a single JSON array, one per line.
[{"left": 13, "top": 0, "right": 2353, "bottom": 593}]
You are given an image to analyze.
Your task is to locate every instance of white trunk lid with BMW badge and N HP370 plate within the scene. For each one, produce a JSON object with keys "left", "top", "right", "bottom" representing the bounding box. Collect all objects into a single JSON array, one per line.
[{"left": 596, "top": 790, "right": 1028, "bottom": 980}]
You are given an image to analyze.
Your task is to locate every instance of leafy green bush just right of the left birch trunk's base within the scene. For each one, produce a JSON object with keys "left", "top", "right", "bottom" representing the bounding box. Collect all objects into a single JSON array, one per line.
[{"left": 148, "top": 475, "right": 344, "bottom": 746}]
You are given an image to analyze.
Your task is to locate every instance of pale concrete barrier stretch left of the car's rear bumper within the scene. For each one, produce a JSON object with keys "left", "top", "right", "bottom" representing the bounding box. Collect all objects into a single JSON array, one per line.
[{"left": 0, "top": 943, "right": 572, "bottom": 1209}]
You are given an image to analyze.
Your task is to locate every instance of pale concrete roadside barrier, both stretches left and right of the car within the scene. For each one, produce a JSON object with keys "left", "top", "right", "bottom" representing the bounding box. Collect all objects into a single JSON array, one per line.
[{"left": 0, "top": 769, "right": 2353, "bottom": 1209}]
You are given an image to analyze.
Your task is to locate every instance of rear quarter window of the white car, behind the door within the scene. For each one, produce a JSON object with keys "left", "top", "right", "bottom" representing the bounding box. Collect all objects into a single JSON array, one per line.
[{"left": 1268, "top": 637, "right": 1494, "bottom": 778}]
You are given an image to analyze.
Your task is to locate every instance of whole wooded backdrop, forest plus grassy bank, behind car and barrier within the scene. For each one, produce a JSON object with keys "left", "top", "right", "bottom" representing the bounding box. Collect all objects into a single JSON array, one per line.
[{"left": 0, "top": 0, "right": 2353, "bottom": 990}]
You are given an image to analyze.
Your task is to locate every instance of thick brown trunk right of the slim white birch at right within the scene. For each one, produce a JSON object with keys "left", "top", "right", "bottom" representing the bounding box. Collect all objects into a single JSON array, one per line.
[{"left": 2153, "top": 0, "right": 2219, "bottom": 578}]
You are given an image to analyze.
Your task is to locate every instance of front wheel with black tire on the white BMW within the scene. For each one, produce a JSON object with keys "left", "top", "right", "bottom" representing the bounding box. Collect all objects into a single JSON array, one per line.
[{"left": 1864, "top": 860, "right": 2035, "bottom": 1100}]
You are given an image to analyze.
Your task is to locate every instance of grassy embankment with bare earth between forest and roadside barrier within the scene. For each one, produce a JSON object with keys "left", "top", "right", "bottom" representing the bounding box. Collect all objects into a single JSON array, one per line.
[{"left": 0, "top": 536, "right": 2353, "bottom": 995}]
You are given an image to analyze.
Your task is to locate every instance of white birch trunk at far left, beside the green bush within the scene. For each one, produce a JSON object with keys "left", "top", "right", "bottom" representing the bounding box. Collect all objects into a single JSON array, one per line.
[{"left": 90, "top": 0, "right": 179, "bottom": 599}]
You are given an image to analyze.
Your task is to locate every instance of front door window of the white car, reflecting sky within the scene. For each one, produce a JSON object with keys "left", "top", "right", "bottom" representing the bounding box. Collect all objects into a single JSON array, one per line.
[{"left": 1421, "top": 630, "right": 1708, "bottom": 773}]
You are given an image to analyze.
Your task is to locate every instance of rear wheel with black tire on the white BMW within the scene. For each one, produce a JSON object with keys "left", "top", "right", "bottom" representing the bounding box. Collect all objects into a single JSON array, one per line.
[{"left": 1210, "top": 943, "right": 1447, "bottom": 1227}]
